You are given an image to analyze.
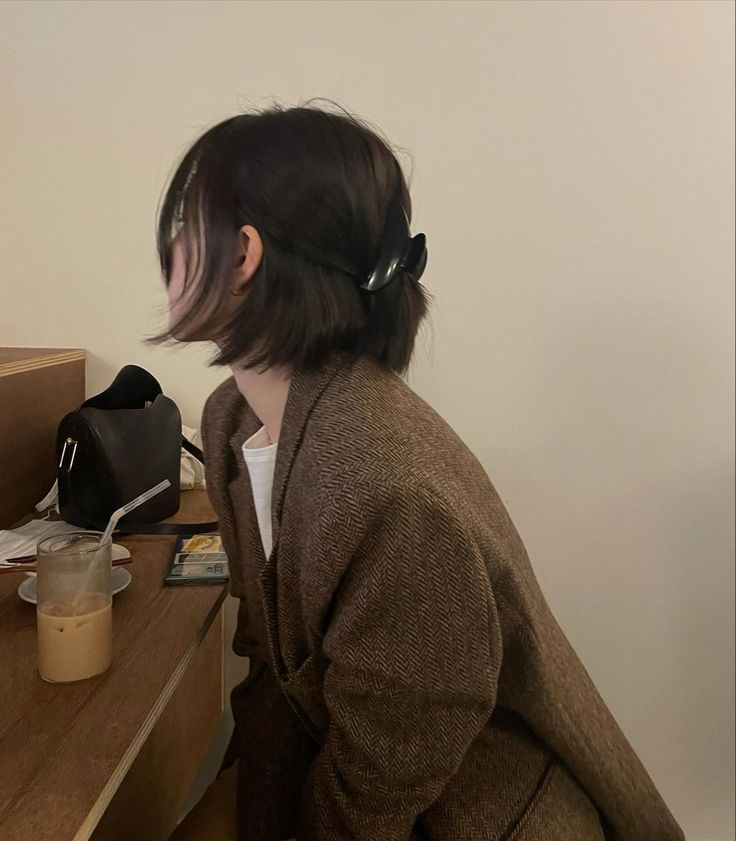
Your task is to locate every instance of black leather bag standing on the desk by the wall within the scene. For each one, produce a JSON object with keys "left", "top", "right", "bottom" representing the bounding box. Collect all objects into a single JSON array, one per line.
[{"left": 56, "top": 365, "right": 217, "bottom": 534}]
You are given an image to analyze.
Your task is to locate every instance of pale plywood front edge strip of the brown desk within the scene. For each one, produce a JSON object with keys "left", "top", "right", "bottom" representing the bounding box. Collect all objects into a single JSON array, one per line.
[{"left": 72, "top": 584, "right": 228, "bottom": 841}]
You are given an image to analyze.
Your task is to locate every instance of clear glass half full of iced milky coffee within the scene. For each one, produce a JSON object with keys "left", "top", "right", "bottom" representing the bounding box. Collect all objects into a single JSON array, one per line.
[{"left": 36, "top": 531, "right": 112, "bottom": 683}]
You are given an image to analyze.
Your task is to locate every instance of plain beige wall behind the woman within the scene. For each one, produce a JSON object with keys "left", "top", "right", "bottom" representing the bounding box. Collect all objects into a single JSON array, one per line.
[{"left": 0, "top": 0, "right": 734, "bottom": 841}]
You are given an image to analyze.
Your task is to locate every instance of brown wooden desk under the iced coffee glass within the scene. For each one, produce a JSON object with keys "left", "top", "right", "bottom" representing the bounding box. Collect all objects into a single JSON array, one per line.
[{"left": 0, "top": 491, "right": 227, "bottom": 841}]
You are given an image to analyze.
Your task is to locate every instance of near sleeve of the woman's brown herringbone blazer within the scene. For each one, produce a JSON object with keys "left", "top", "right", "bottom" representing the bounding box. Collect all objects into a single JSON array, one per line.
[{"left": 297, "top": 492, "right": 501, "bottom": 841}]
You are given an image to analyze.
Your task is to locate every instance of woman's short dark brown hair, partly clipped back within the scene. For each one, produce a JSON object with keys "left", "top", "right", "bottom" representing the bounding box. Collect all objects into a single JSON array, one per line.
[{"left": 147, "top": 100, "right": 430, "bottom": 373}]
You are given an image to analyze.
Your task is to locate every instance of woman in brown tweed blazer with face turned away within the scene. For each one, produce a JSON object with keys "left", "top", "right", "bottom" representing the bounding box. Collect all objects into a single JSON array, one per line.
[{"left": 158, "top": 105, "right": 683, "bottom": 841}]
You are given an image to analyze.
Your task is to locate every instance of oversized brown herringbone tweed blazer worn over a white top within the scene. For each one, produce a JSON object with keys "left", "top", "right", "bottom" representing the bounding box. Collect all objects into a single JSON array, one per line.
[{"left": 202, "top": 354, "right": 683, "bottom": 841}]
